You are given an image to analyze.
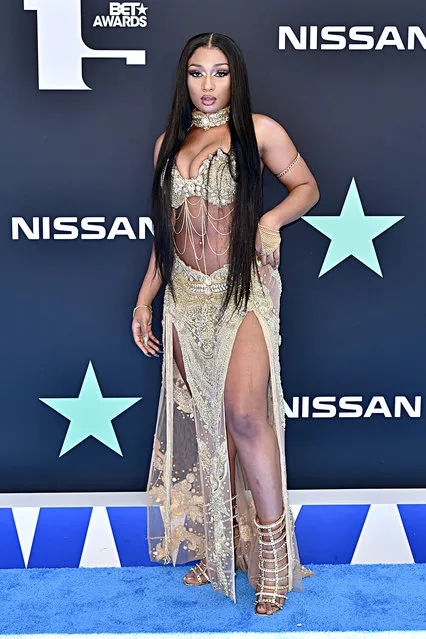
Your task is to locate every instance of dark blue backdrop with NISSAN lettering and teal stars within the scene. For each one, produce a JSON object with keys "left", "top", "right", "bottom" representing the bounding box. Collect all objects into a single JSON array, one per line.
[{"left": 0, "top": 0, "right": 426, "bottom": 493}]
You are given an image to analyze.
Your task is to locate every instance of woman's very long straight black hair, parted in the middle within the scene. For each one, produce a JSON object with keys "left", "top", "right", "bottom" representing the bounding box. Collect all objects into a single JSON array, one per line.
[{"left": 152, "top": 33, "right": 262, "bottom": 308}]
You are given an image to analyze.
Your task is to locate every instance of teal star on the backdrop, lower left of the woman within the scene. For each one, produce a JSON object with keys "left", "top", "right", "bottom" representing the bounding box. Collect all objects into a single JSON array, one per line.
[{"left": 39, "top": 362, "right": 142, "bottom": 457}]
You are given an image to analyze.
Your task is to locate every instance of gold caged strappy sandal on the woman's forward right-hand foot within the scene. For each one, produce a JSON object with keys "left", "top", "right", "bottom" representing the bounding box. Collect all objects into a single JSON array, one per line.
[{"left": 254, "top": 511, "right": 288, "bottom": 615}]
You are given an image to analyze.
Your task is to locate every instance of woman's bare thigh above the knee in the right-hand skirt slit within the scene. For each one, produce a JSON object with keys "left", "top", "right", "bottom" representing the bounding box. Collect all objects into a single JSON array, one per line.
[{"left": 224, "top": 311, "right": 269, "bottom": 431}]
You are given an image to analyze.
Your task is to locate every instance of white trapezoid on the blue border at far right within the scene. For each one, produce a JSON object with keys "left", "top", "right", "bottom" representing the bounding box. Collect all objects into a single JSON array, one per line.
[{"left": 351, "top": 504, "right": 414, "bottom": 564}]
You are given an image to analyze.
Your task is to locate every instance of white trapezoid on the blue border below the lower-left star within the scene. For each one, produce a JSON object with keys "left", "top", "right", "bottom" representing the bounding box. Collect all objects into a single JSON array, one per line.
[{"left": 80, "top": 506, "right": 121, "bottom": 568}]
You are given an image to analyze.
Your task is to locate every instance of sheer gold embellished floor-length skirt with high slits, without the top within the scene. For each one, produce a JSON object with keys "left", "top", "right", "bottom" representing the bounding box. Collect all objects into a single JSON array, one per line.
[{"left": 147, "top": 259, "right": 302, "bottom": 601}]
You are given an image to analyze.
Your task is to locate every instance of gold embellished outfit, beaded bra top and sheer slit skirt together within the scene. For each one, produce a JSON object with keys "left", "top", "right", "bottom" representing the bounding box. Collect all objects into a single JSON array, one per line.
[{"left": 147, "top": 148, "right": 309, "bottom": 601}]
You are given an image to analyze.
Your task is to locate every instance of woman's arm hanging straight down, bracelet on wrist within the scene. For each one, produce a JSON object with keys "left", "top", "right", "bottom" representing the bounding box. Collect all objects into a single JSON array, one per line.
[{"left": 132, "top": 133, "right": 164, "bottom": 357}]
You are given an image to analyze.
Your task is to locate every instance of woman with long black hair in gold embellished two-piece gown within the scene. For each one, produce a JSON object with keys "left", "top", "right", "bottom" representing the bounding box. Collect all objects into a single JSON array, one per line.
[{"left": 132, "top": 34, "right": 319, "bottom": 614}]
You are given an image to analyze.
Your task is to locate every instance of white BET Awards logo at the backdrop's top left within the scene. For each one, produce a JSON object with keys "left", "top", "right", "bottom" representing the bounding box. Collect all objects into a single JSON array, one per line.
[{"left": 24, "top": 0, "right": 146, "bottom": 91}]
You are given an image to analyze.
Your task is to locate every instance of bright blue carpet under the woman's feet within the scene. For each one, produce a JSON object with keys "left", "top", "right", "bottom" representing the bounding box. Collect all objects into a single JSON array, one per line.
[{"left": 0, "top": 564, "right": 426, "bottom": 635}]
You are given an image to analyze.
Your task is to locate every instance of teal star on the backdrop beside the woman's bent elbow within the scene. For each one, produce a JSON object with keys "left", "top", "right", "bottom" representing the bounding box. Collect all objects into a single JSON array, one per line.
[{"left": 302, "top": 178, "right": 405, "bottom": 277}]
